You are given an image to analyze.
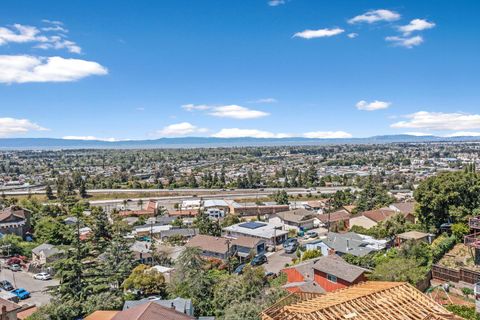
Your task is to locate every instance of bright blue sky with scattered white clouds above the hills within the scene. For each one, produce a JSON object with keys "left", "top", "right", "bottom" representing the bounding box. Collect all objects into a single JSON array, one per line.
[{"left": 0, "top": 0, "right": 480, "bottom": 140}]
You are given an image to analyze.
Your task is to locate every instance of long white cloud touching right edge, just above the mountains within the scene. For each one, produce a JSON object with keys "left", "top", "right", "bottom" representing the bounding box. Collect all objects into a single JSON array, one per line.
[{"left": 391, "top": 111, "right": 480, "bottom": 131}]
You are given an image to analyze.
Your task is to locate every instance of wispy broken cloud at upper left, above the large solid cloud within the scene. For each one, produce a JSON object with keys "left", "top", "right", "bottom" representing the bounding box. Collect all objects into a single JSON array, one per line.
[{"left": 0, "top": 20, "right": 82, "bottom": 54}]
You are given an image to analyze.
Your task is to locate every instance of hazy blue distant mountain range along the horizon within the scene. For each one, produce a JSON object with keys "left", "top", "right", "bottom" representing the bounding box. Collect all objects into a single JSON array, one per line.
[{"left": 0, "top": 134, "right": 480, "bottom": 150}]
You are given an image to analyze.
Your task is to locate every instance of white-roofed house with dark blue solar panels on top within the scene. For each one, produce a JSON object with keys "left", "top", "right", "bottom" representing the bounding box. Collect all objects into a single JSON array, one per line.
[{"left": 223, "top": 221, "right": 288, "bottom": 245}]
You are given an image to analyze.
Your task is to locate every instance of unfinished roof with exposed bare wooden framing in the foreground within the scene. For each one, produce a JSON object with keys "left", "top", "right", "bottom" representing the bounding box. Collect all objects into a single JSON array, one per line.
[{"left": 261, "top": 281, "right": 461, "bottom": 320}]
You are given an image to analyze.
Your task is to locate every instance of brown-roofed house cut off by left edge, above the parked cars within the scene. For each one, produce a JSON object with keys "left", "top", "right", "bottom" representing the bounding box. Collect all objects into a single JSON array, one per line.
[{"left": 0, "top": 206, "right": 31, "bottom": 238}]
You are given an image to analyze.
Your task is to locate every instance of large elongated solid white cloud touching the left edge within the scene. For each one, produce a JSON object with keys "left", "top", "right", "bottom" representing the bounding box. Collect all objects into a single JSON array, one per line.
[{"left": 0, "top": 55, "right": 108, "bottom": 83}]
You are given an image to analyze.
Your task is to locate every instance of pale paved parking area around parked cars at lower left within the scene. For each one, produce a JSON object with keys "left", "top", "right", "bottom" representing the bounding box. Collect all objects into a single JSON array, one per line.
[{"left": 0, "top": 269, "right": 58, "bottom": 306}]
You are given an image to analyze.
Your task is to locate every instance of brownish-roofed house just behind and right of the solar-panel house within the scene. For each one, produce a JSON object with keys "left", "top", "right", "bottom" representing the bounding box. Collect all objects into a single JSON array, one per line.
[{"left": 268, "top": 209, "right": 318, "bottom": 231}]
